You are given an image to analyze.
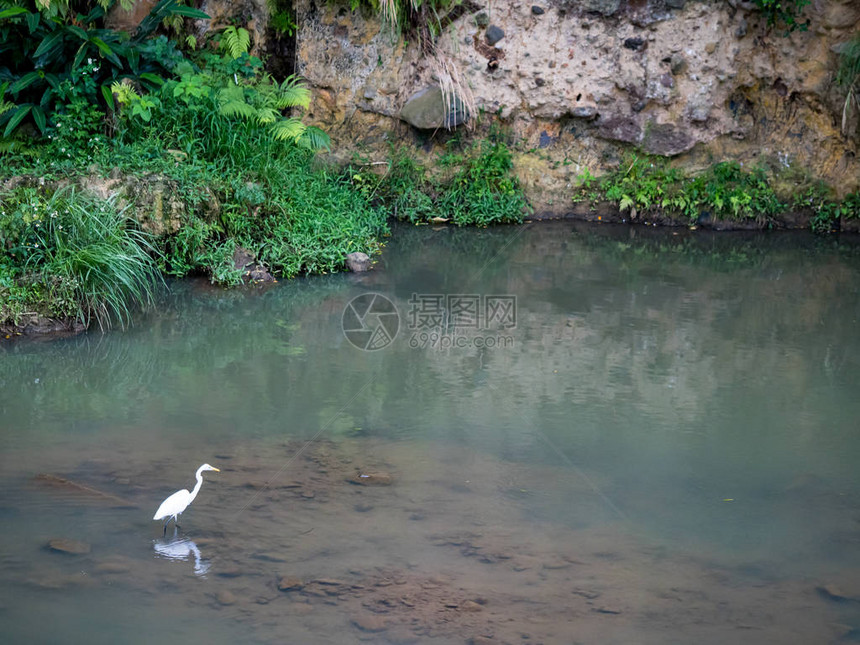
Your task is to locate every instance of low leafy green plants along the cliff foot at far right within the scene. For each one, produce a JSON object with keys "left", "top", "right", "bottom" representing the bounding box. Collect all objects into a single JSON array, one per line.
[{"left": 574, "top": 155, "right": 860, "bottom": 232}]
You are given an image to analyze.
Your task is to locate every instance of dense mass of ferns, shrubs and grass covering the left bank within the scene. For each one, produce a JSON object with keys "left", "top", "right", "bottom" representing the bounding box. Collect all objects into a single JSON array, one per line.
[{"left": 0, "top": 0, "right": 372, "bottom": 326}]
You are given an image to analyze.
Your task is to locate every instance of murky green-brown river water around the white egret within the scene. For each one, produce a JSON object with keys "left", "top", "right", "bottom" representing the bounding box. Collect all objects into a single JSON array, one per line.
[{"left": 0, "top": 223, "right": 860, "bottom": 644}]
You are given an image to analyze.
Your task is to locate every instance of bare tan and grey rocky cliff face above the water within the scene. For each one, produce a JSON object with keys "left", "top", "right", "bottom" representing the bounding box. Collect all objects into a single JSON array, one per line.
[{"left": 296, "top": 0, "right": 860, "bottom": 212}]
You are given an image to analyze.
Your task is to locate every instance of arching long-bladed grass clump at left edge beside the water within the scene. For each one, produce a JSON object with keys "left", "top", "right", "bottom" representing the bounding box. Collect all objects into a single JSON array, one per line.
[{"left": 0, "top": 188, "right": 160, "bottom": 328}]
